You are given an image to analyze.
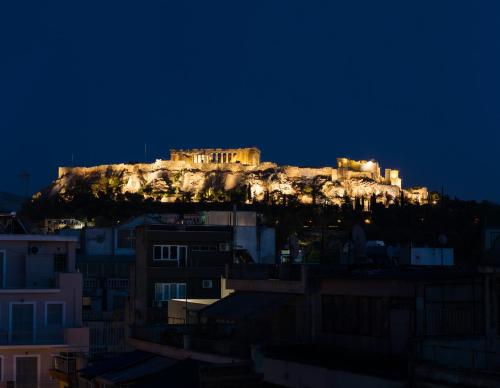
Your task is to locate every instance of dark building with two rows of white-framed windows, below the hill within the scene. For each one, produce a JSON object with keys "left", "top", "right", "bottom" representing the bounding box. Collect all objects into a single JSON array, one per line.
[{"left": 129, "top": 225, "right": 233, "bottom": 325}]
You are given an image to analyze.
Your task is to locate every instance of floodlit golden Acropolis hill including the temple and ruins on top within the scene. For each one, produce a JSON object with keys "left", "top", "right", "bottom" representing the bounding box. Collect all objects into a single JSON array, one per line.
[{"left": 55, "top": 147, "right": 427, "bottom": 205}]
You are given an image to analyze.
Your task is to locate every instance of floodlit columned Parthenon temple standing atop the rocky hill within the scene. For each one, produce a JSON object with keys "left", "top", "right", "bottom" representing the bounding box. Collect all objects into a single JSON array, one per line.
[{"left": 170, "top": 147, "right": 260, "bottom": 166}]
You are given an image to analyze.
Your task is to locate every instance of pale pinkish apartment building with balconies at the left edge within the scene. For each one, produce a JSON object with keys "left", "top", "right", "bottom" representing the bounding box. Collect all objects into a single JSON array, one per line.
[{"left": 0, "top": 234, "right": 89, "bottom": 387}]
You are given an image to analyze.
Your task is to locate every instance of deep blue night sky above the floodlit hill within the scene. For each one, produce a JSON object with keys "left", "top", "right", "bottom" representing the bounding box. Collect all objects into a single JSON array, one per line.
[{"left": 0, "top": 0, "right": 500, "bottom": 201}]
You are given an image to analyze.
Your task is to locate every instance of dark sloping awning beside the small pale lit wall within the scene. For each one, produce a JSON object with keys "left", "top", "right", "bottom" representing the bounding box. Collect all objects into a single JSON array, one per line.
[{"left": 199, "top": 291, "right": 298, "bottom": 320}]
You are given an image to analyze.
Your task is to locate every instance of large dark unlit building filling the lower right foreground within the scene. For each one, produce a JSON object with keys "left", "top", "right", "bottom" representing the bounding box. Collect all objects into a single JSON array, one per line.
[{"left": 131, "top": 264, "right": 500, "bottom": 388}]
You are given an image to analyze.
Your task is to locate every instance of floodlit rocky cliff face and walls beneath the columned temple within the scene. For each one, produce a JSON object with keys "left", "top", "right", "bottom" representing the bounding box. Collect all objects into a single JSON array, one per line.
[{"left": 44, "top": 160, "right": 427, "bottom": 205}]
